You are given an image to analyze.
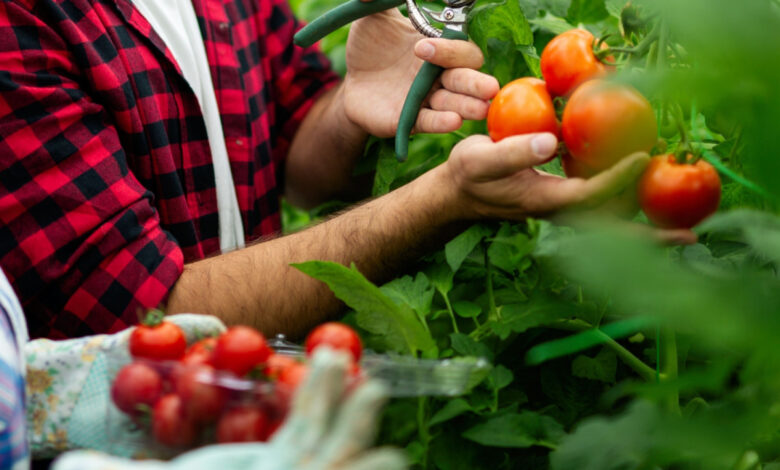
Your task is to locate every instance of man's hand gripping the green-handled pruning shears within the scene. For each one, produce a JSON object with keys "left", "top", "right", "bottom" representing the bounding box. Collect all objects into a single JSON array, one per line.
[{"left": 342, "top": 8, "right": 499, "bottom": 137}]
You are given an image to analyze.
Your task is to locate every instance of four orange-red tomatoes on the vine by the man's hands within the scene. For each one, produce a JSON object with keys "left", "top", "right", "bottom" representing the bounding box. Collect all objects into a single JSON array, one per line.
[{"left": 487, "top": 29, "right": 720, "bottom": 228}]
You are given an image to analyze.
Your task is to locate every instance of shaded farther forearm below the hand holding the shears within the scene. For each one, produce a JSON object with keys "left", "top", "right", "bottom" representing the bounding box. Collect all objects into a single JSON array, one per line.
[{"left": 285, "top": 86, "right": 370, "bottom": 208}]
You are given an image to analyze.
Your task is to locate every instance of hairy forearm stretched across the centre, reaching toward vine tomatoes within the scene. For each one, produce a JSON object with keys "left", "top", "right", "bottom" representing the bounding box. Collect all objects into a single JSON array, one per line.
[{"left": 168, "top": 167, "right": 461, "bottom": 336}]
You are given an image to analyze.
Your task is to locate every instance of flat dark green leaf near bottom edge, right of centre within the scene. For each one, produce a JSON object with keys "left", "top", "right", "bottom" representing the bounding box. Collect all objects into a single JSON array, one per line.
[{"left": 463, "top": 411, "right": 574, "bottom": 448}]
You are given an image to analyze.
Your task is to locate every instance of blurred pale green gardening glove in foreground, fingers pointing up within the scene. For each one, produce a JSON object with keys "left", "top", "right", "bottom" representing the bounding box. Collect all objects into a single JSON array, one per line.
[{"left": 48, "top": 348, "right": 407, "bottom": 470}]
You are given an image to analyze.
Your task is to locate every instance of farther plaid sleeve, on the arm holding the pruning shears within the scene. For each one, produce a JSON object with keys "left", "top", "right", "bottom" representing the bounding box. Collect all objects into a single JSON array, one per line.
[{"left": 266, "top": 0, "right": 339, "bottom": 162}]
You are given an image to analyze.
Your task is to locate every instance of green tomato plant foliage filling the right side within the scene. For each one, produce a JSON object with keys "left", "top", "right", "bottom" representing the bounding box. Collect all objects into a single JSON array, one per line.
[{"left": 284, "top": 0, "right": 780, "bottom": 470}]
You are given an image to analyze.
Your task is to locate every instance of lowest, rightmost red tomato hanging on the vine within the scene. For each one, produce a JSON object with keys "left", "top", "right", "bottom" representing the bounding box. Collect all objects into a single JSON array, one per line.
[{"left": 637, "top": 155, "right": 720, "bottom": 228}]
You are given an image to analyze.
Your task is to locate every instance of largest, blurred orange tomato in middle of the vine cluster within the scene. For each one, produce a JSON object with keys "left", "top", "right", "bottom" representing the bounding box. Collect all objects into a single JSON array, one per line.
[{"left": 562, "top": 80, "right": 657, "bottom": 171}]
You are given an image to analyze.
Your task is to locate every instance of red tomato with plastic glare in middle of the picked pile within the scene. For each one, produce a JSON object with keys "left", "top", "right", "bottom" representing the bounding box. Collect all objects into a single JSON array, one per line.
[{"left": 175, "top": 364, "right": 228, "bottom": 423}]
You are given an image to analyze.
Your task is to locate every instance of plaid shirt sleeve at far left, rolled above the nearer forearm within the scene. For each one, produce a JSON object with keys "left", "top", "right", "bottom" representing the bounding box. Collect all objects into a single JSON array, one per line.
[{"left": 0, "top": 1, "right": 183, "bottom": 338}]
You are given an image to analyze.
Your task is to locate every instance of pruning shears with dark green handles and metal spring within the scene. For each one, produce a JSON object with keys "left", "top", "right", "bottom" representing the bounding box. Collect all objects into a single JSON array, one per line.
[{"left": 294, "top": 0, "right": 476, "bottom": 161}]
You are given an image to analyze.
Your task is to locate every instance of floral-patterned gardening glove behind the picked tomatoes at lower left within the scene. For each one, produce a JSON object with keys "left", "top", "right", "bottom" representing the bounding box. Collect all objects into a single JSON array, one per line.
[{"left": 24, "top": 314, "right": 225, "bottom": 458}]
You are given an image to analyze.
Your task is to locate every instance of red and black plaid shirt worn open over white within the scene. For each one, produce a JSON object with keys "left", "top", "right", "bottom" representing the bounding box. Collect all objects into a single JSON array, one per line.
[{"left": 0, "top": 0, "right": 337, "bottom": 338}]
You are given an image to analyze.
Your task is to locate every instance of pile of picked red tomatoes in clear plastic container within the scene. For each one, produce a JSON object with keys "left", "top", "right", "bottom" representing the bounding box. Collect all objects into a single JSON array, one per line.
[{"left": 111, "top": 313, "right": 362, "bottom": 448}]
